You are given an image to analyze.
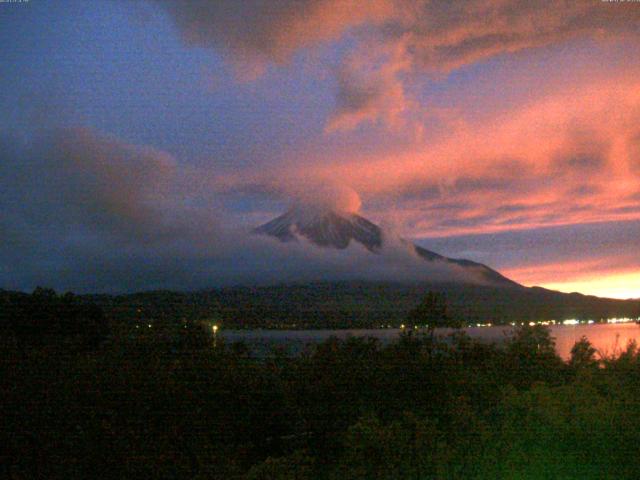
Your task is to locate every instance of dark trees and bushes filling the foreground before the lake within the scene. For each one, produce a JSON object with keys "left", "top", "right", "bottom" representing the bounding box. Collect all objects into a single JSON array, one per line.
[{"left": 0, "top": 291, "right": 640, "bottom": 480}]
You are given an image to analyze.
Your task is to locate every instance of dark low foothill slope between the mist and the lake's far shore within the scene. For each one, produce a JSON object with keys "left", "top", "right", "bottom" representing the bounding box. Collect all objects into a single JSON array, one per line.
[{"left": 81, "top": 282, "right": 640, "bottom": 328}]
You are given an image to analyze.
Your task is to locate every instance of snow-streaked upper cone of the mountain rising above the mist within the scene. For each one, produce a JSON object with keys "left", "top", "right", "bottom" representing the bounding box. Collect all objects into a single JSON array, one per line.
[{"left": 253, "top": 205, "right": 522, "bottom": 288}]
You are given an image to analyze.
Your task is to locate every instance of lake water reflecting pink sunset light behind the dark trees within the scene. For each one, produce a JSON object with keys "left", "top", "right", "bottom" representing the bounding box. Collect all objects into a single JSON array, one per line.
[{"left": 217, "top": 323, "right": 640, "bottom": 359}]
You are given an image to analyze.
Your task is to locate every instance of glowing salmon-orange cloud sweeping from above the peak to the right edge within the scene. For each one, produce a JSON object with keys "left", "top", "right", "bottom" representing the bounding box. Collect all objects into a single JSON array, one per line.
[{"left": 219, "top": 75, "right": 640, "bottom": 236}]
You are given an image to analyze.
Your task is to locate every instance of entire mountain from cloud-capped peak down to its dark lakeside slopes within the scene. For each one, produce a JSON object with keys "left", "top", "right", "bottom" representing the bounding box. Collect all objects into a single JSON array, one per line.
[{"left": 76, "top": 206, "right": 640, "bottom": 329}]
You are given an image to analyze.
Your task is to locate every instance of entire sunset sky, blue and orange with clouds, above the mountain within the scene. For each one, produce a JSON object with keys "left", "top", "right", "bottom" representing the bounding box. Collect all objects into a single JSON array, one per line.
[{"left": 0, "top": 0, "right": 640, "bottom": 298}]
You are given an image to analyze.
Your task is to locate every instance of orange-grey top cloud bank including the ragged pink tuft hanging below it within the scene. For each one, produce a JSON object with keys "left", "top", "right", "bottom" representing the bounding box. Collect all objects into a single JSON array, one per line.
[{"left": 156, "top": 0, "right": 640, "bottom": 127}]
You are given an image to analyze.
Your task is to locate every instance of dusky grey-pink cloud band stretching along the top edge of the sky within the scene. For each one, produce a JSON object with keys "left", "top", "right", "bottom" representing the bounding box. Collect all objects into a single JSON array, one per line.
[{"left": 154, "top": 0, "right": 640, "bottom": 71}]
